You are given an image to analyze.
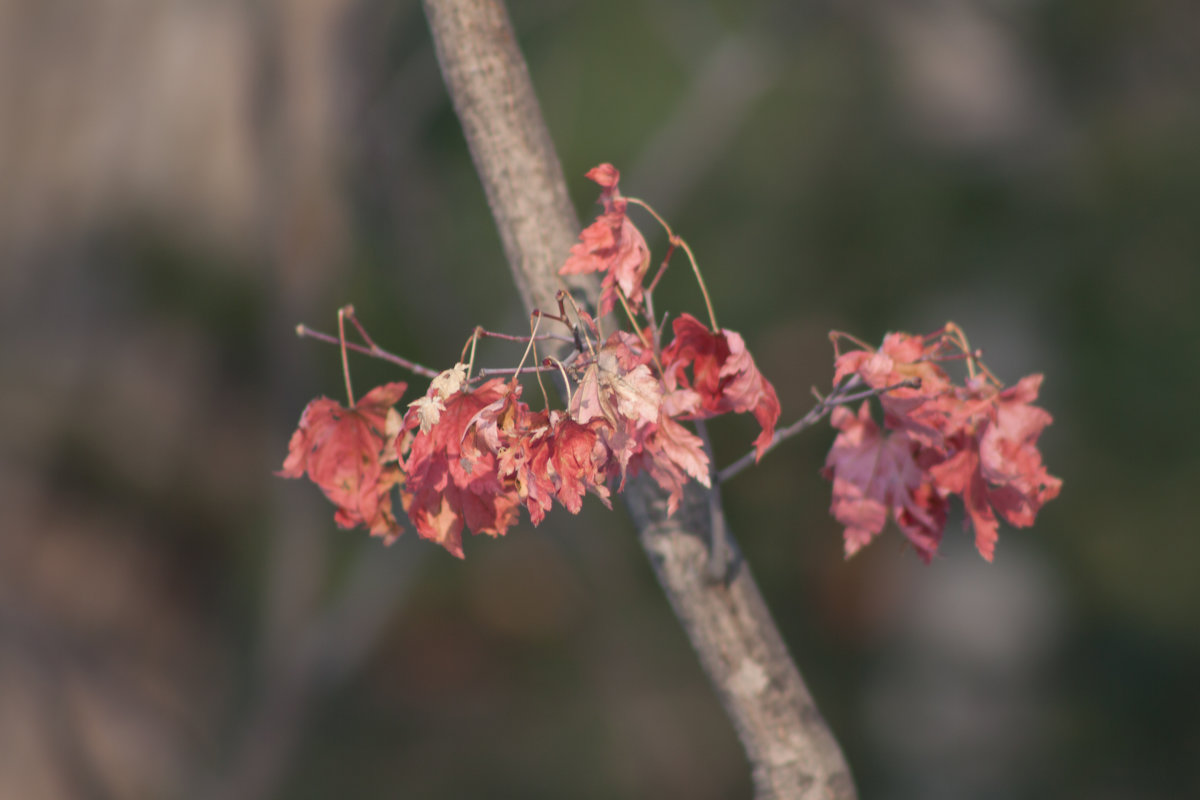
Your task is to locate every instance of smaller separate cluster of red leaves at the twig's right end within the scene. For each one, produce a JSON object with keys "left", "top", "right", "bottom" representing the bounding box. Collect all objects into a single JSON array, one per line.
[{"left": 823, "top": 326, "right": 1062, "bottom": 563}]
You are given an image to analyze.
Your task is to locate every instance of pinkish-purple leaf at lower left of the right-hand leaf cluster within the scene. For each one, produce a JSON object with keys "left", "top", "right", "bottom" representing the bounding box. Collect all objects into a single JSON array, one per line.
[{"left": 822, "top": 403, "right": 946, "bottom": 564}]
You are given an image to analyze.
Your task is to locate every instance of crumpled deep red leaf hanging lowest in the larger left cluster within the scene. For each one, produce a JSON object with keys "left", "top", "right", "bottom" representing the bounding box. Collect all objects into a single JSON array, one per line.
[{"left": 401, "top": 378, "right": 520, "bottom": 558}]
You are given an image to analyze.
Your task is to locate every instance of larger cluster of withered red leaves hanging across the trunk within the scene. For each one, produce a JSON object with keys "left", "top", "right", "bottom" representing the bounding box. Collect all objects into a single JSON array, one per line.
[{"left": 281, "top": 164, "right": 780, "bottom": 558}]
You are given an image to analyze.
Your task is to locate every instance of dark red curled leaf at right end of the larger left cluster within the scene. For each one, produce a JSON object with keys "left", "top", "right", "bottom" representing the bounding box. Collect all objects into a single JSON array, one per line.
[{"left": 662, "top": 313, "right": 780, "bottom": 458}]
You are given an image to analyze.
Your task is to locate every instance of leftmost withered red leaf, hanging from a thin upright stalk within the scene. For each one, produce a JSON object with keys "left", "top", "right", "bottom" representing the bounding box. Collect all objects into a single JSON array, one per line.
[{"left": 276, "top": 383, "right": 407, "bottom": 543}]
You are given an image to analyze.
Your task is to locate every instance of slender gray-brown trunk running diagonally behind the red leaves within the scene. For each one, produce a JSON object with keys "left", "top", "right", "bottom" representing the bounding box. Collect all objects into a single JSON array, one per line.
[{"left": 425, "top": 0, "right": 856, "bottom": 800}]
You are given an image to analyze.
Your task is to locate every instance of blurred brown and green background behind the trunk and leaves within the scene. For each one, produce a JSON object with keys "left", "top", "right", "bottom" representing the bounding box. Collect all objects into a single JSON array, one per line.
[{"left": 0, "top": 0, "right": 1200, "bottom": 800}]
